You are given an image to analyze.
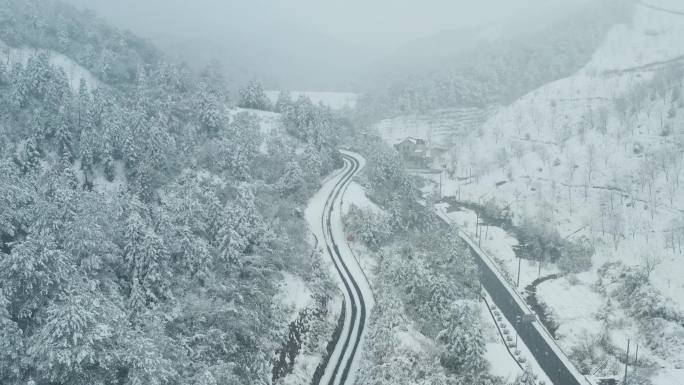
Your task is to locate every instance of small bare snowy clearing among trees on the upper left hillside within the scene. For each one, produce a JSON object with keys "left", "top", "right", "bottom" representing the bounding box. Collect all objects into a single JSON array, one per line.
[{"left": 0, "top": 41, "right": 99, "bottom": 91}]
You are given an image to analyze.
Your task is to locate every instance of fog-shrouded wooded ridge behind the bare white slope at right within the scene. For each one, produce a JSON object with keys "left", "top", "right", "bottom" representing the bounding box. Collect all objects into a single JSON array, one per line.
[{"left": 359, "top": 0, "right": 630, "bottom": 120}]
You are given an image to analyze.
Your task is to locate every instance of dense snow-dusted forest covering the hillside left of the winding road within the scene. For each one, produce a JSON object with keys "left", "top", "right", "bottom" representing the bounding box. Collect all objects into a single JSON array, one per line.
[{"left": 0, "top": 0, "right": 342, "bottom": 385}]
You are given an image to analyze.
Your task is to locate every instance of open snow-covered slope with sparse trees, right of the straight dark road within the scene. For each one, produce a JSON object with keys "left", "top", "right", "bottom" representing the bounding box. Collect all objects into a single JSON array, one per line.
[{"left": 436, "top": 0, "right": 684, "bottom": 384}]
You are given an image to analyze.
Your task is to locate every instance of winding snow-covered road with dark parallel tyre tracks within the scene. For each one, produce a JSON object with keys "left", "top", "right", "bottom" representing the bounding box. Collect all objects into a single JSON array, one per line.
[{"left": 306, "top": 151, "right": 373, "bottom": 385}]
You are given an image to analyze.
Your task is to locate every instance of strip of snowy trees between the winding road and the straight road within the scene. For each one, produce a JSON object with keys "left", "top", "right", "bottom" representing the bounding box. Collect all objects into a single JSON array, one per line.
[{"left": 344, "top": 140, "right": 505, "bottom": 385}]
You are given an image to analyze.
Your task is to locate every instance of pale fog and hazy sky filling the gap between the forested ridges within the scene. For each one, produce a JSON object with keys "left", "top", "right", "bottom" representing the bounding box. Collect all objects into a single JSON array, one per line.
[{"left": 62, "top": 0, "right": 576, "bottom": 91}]
